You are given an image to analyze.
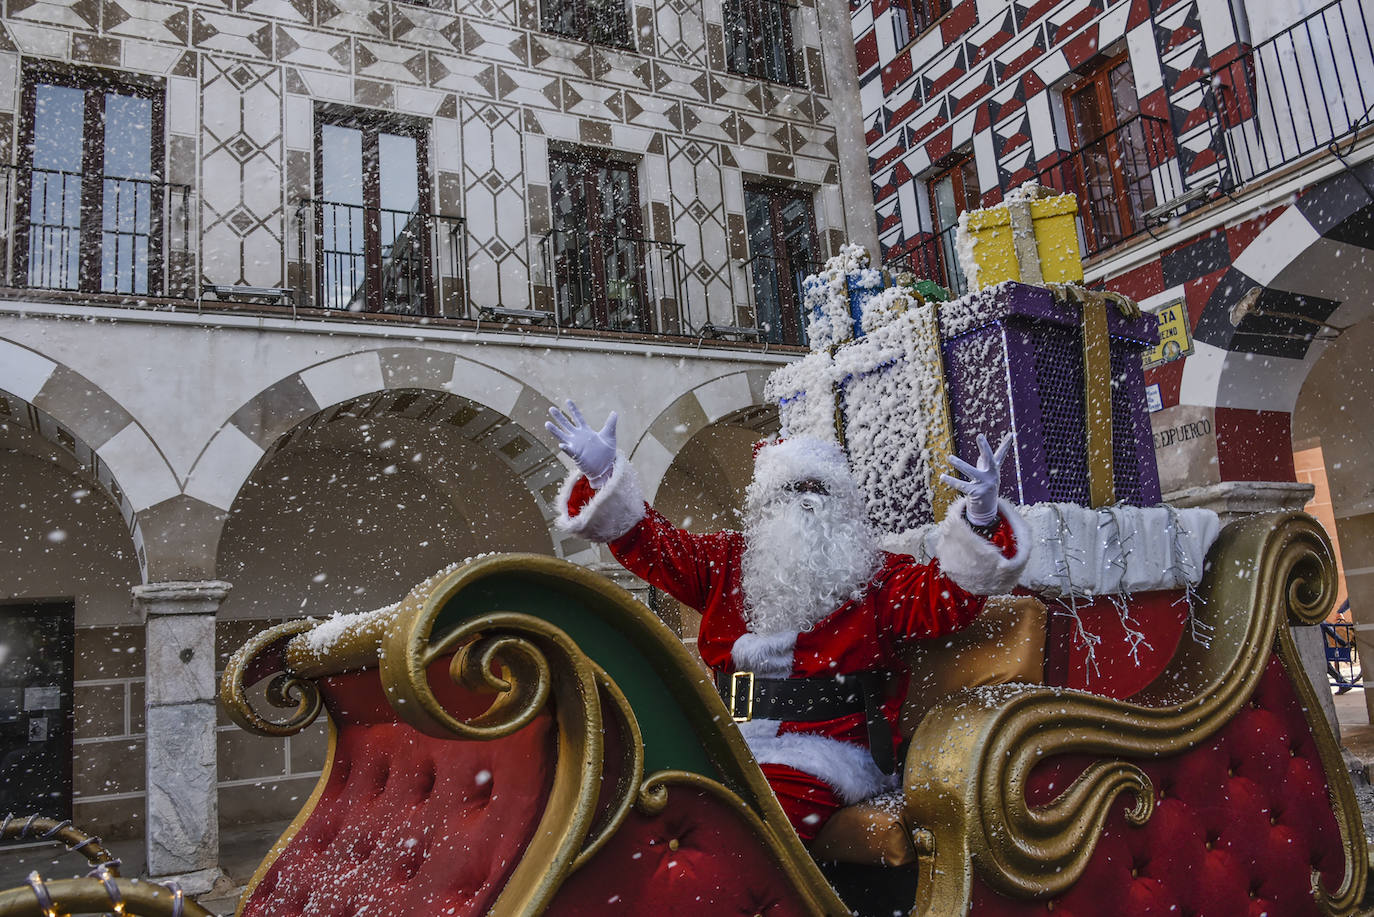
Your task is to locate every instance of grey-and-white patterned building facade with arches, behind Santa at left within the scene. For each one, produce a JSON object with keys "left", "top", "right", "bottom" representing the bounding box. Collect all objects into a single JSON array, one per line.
[{"left": 0, "top": 0, "right": 877, "bottom": 891}]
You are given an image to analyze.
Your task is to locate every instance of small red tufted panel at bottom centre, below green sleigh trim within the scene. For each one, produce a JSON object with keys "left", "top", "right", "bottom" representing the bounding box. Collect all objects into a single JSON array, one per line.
[{"left": 545, "top": 786, "right": 812, "bottom": 917}]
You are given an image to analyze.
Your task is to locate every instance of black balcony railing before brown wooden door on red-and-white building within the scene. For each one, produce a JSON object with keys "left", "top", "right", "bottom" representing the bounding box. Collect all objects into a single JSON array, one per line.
[{"left": 1039, "top": 114, "right": 1183, "bottom": 256}]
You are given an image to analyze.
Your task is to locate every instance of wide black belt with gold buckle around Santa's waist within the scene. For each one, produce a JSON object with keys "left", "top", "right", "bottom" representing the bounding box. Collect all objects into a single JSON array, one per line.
[{"left": 716, "top": 672, "right": 896, "bottom": 774}]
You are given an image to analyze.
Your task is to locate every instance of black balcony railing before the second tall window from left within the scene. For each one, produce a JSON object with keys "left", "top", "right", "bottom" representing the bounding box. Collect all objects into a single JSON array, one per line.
[{"left": 291, "top": 201, "right": 469, "bottom": 318}]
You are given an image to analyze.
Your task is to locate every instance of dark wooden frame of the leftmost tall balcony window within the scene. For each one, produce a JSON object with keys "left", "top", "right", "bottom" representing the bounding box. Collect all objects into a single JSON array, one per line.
[{"left": 14, "top": 60, "right": 166, "bottom": 296}]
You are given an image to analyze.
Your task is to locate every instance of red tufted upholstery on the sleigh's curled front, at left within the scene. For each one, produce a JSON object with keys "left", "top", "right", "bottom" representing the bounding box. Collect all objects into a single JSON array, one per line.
[{"left": 242, "top": 661, "right": 554, "bottom": 917}]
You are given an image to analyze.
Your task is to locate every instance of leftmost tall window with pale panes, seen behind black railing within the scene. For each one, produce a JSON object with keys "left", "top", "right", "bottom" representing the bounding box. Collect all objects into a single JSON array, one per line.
[{"left": 19, "top": 65, "right": 174, "bottom": 296}]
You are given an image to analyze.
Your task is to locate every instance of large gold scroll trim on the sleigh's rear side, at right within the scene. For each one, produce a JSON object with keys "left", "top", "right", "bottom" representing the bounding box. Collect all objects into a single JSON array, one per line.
[{"left": 905, "top": 513, "right": 1369, "bottom": 914}]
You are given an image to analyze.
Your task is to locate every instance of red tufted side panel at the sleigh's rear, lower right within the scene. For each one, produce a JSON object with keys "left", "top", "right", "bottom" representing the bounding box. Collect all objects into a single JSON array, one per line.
[{"left": 973, "top": 656, "right": 1344, "bottom": 917}]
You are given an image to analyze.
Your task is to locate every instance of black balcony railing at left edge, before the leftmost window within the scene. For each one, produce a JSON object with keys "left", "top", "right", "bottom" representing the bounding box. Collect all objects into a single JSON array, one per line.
[{"left": 0, "top": 165, "right": 196, "bottom": 298}]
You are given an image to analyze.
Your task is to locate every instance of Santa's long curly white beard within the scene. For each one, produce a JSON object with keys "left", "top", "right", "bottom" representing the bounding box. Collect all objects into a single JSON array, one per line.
[{"left": 741, "top": 494, "right": 879, "bottom": 634}]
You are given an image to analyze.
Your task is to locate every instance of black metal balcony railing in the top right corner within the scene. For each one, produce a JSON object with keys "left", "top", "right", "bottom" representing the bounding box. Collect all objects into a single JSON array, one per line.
[{"left": 1209, "top": 0, "right": 1374, "bottom": 188}]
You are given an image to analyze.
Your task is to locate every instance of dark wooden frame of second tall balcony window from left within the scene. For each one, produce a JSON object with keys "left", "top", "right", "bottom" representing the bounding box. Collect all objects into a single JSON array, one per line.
[{"left": 315, "top": 102, "right": 434, "bottom": 315}]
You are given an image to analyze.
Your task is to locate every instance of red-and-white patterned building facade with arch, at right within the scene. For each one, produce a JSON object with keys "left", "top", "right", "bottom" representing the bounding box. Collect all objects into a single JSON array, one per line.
[{"left": 851, "top": 0, "right": 1374, "bottom": 698}]
